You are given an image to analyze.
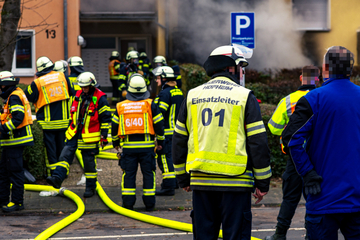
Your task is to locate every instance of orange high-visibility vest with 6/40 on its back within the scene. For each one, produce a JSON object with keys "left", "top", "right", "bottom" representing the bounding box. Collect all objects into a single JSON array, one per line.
[{"left": 116, "top": 99, "right": 155, "bottom": 138}]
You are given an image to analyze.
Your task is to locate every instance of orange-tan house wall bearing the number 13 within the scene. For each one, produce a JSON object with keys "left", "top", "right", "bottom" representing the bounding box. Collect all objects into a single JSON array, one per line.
[{"left": 20, "top": 0, "right": 80, "bottom": 84}]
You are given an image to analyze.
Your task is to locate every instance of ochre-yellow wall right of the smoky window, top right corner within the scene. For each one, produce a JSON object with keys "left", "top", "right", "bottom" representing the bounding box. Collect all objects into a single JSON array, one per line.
[{"left": 307, "top": 0, "right": 360, "bottom": 65}]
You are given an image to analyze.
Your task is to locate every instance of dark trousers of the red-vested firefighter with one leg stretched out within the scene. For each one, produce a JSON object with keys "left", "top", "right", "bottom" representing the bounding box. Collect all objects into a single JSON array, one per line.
[{"left": 53, "top": 134, "right": 99, "bottom": 189}]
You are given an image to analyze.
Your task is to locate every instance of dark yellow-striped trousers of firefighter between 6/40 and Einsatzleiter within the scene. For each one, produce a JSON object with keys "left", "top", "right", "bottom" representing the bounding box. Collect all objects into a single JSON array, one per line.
[{"left": 157, "top": 138, "right": 176, "bottom": 189}]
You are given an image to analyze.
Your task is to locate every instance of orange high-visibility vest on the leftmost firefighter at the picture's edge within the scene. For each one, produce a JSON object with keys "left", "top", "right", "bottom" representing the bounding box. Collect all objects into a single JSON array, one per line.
[{"left": 0, "top": 88, "right": 33, "bottom": 129}]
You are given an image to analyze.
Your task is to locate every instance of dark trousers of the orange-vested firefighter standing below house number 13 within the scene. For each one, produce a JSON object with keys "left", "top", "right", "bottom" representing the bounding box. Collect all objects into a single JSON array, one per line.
[{"left": 43, "top": 129, "right": 66, "bottom": 176}]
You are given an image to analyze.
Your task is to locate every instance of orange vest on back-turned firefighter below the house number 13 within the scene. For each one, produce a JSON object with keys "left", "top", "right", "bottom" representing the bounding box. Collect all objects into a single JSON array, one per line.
[{"left": 34, "top": 71, "right": 70, "bottom": 111}]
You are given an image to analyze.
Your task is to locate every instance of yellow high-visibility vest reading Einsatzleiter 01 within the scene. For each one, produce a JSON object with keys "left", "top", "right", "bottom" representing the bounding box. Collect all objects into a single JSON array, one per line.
[{"left": 186, "top": 77, "right": 250, "bottom": 176}]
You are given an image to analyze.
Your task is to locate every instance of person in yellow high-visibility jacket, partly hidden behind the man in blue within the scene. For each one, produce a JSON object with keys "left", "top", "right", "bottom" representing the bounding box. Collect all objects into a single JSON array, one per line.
[{"left": 265, "top": 66, "right": 320, "bottom": 240}]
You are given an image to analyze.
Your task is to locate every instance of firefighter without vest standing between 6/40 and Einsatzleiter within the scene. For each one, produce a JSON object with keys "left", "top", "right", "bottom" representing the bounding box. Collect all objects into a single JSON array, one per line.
[{"left": 153, "top": 66, "right": 184, "bottom": 196}]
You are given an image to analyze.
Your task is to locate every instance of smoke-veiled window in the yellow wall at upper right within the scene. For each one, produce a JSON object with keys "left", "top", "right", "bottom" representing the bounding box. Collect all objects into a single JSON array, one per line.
[{"left": 292, "top": 0, "right": 330, "bottom": 31}]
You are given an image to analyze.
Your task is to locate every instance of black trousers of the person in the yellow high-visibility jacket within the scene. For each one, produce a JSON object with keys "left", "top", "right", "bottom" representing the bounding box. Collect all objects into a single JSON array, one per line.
[{"left": 277, "top": 159, "right": 303, "bottom": 228}]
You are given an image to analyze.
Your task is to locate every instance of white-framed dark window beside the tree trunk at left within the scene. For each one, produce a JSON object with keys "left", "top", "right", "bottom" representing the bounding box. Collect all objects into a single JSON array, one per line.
[{"left": 11, "top": 30, "right": 36, "bottom": 76}]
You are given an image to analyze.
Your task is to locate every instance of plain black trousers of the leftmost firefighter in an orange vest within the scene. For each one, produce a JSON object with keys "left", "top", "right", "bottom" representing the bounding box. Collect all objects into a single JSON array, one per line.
[{"left": 0, "top": 147, "right": 24, "bottom": 204}]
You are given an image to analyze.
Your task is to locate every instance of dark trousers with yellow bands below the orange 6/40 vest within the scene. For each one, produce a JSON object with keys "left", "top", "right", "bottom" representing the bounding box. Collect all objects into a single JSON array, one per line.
[{"left": 119, "top": 151, "right": 156, "bottom": 210}]
